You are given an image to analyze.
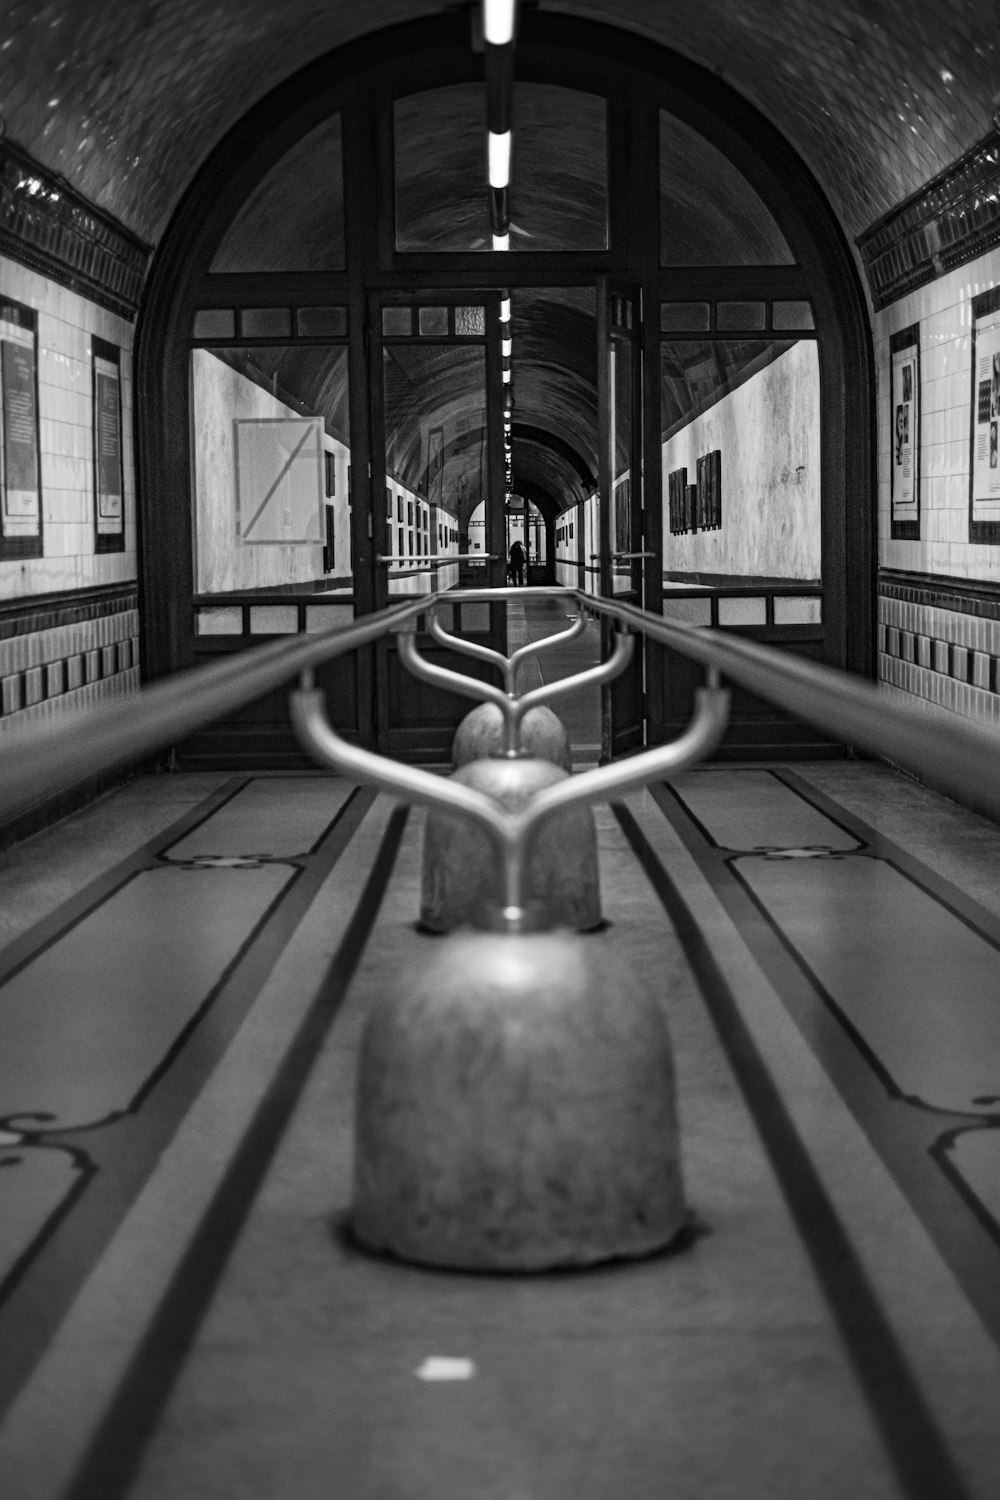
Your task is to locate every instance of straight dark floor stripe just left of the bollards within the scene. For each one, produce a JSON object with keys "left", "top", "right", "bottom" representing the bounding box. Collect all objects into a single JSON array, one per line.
[{"left": 64, "top": 807, "right": 409, "bottom": 1500}]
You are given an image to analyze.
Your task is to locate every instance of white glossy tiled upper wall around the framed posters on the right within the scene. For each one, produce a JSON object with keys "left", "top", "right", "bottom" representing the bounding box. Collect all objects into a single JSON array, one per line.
[{"left": 874, "top": 249, "right": 1000, "bottom": 722}]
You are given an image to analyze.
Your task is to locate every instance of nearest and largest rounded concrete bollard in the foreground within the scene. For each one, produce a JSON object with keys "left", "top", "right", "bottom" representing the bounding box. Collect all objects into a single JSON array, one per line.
[{"left": 351, "top": 930, "right": 687, "bottom": 1271}]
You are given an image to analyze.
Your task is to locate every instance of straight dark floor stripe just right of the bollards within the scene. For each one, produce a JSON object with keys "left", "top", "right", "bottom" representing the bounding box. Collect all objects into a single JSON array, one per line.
[{"left": 614, "top": 804, "right": 969, "bottom": 1500}]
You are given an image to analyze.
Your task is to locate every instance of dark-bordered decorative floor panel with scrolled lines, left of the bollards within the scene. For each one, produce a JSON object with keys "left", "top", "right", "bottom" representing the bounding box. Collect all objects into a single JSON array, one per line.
[{"left": 0, "top": 776, "right": 373, "bottom": 1409}]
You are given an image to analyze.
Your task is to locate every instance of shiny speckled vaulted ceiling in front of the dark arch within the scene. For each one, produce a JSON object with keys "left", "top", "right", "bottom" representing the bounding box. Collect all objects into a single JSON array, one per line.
[{"left": 0, "top": 0, "right": 1000, "bottom": 242}]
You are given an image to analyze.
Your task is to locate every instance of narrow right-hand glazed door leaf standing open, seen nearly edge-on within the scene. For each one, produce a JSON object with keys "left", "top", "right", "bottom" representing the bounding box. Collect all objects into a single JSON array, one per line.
[{"left": 597, "top": 278, "right": 644, "bottom": 759}]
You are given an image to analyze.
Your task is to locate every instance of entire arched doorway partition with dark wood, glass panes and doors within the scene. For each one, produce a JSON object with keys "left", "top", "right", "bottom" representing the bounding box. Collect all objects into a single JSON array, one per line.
[{"left": 136, "top": 12, "right": 873, "bottom": 765}]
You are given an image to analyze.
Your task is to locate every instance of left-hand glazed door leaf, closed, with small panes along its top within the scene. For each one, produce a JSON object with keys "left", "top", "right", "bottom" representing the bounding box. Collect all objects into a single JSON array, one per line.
[{"left": 369, "top": 291, "right": 507, "bottom": 762}]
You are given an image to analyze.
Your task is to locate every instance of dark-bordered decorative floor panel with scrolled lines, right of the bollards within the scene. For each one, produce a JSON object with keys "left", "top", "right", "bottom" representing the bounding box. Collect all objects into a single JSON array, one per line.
[{"left": 654, "top": 768, "right": 1000, "bottom": 1343}]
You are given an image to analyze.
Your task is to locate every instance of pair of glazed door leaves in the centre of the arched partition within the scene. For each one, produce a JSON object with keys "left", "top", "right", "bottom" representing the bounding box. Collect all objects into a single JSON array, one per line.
[{"left": 367, "top": 278, "right": 657, "bottom": 761}]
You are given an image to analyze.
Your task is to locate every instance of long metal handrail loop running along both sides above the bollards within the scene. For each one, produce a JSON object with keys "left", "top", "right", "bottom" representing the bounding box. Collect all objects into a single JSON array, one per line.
[{"left": 0, "top": 585, "right": 1000, "bottom": 822}]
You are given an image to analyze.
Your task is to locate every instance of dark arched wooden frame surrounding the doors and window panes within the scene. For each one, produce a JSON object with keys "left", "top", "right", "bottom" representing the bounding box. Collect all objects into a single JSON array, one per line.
[{"left": 135, "top": 11, "right": 876, "bottom": 762}]
